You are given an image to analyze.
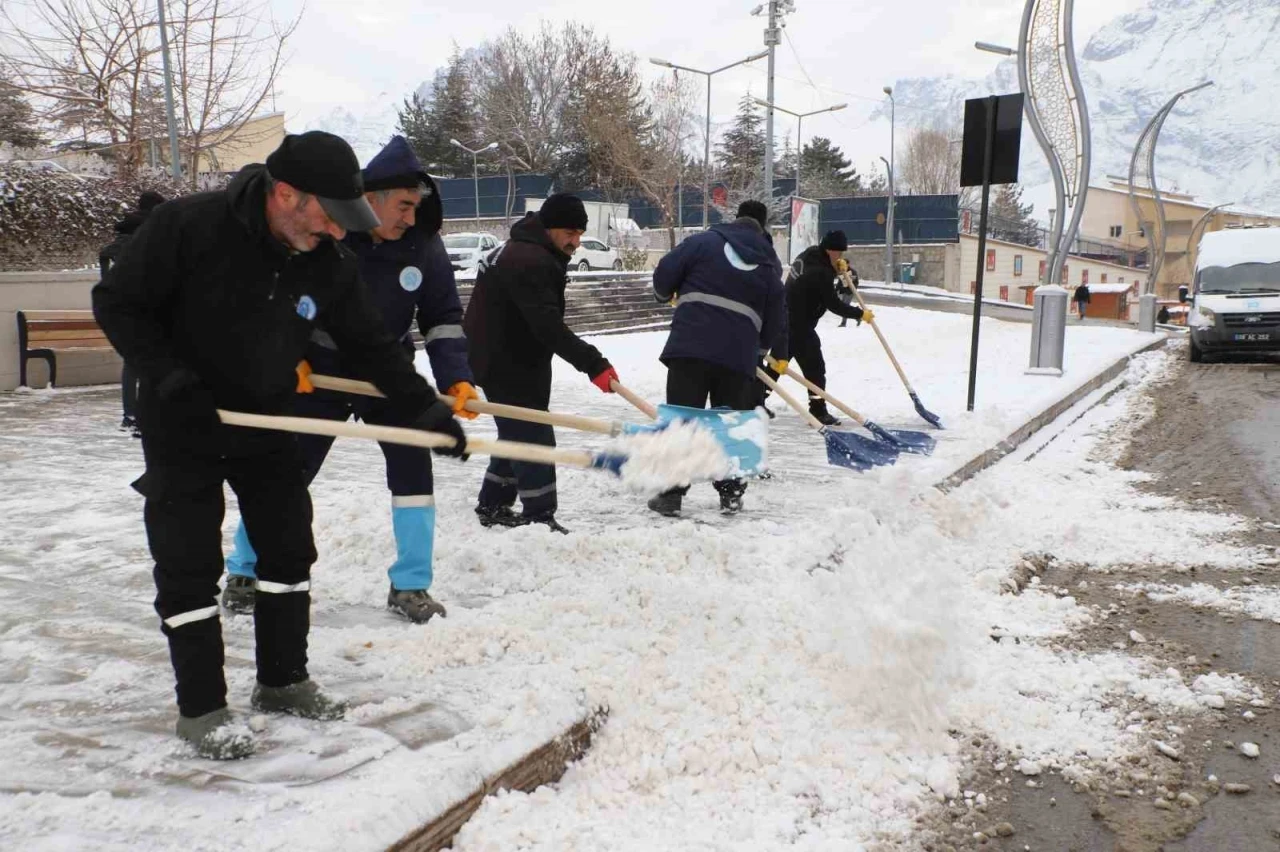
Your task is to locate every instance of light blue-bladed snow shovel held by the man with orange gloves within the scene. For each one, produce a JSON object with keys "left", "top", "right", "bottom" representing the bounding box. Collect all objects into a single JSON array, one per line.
[{"left": 310, "top": 374, "right": 768, "bottom": 476}]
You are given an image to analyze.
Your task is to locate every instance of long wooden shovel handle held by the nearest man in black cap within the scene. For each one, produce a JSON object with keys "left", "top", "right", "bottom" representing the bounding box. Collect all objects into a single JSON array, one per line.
[{"left": 218, "top": 409, "right": 594, "bottom": 468}]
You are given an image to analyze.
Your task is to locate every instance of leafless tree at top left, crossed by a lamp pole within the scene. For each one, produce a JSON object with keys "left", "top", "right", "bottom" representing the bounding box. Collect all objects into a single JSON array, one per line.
[{"left": 0, "top": 0, "right": 297, "bottom": 180}]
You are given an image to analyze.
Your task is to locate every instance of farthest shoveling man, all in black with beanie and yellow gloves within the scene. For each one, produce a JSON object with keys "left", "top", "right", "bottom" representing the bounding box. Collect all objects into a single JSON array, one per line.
[{"left": 769, "top": 230, "right": 873, "bottom": 426}]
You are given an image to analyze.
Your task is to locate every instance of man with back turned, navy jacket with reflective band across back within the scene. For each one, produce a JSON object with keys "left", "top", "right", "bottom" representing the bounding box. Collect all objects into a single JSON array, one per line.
[{"left": 649, "top": 201, "right": 787, "bottom": 517}]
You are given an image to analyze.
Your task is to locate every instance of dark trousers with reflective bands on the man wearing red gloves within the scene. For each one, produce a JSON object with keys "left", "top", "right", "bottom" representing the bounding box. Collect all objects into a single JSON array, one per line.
[{"left": 477, "top": 376, "right": 559, "bottom": 517}]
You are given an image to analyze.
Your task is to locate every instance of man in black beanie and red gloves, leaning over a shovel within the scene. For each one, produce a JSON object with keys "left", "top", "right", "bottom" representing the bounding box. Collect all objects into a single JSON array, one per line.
[{"left": 463, "top": 194, "right": 618, "bottom": 532}]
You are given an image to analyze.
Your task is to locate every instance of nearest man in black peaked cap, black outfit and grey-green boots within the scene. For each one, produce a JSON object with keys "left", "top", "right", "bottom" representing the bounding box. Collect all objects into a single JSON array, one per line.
[{"left": 93, "top": 132, "right": 466, "bottom": 759}]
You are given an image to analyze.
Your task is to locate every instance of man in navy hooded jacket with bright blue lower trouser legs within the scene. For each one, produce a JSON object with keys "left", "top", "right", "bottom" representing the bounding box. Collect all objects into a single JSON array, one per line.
[{"left": 223, "top": 136, "right": 479, "bottom": 623}]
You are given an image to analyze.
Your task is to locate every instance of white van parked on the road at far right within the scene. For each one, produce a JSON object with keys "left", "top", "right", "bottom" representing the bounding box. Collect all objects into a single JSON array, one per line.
[{"left": 1179, "top": 228, "right": 1280, "bottom": 362}]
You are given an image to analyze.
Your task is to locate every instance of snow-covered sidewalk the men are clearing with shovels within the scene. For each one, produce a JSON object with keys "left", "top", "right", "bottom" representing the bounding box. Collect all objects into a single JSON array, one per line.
[{"left": 0, "top": 308, "right": 1156, "bottom": 851}]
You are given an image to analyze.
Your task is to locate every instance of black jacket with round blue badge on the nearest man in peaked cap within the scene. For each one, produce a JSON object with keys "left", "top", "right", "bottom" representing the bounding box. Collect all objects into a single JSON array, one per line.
[{"left": 93, "top": 165, "right": 439, "bottom": 445}]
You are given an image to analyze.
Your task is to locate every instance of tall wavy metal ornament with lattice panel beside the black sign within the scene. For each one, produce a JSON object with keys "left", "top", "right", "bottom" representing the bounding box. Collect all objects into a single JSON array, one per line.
[{"left": 1018, "top": 0, "right": 1092, "bottom": 284}]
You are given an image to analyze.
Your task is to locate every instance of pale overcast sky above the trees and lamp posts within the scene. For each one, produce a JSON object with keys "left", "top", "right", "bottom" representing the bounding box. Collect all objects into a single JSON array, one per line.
[{"left": 271, "top": 0, "right": 1142, "bottom": 170}]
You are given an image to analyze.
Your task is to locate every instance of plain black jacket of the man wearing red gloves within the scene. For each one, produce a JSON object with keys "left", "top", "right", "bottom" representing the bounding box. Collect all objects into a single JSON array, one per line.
[{"left": 463, "top": 214, "right": 609, "bottom": 389}]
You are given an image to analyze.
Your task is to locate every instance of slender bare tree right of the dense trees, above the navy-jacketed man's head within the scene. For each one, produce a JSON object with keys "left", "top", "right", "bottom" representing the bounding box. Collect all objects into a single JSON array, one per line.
[{"left": 584, "top": 71, "right": 698, "bottom": 248}]
